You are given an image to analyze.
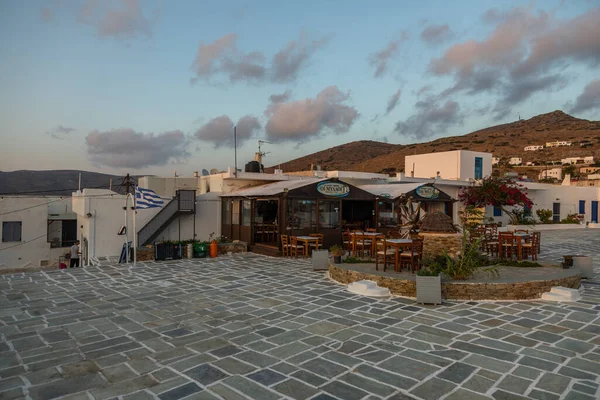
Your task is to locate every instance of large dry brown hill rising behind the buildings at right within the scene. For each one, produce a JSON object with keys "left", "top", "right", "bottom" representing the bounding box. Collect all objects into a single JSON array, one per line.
[{"left": 269, "top": 110, "right": 600, "bottom": 173}]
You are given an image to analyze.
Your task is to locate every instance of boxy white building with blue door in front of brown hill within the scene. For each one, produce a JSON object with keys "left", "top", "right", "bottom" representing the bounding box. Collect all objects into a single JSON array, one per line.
[{"left": 404, "top": 150, "right": 492, "bottom": 181}]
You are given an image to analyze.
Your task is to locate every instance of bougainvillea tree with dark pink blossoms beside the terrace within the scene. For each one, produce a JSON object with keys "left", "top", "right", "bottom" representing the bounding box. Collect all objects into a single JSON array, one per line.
[{"left": 458, "top": 176, "right": 533, "bottom": 225}]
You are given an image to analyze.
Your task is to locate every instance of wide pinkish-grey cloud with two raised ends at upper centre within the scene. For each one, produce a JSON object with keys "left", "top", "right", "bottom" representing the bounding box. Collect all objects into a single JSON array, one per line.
[{"left": 191, "top": 33, "right": 329, "bottom": 83}]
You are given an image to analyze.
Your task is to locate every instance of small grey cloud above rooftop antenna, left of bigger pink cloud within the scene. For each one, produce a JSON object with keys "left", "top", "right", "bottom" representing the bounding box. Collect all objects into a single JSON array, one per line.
[{"left": 194, "top": 115, "right": 261, "bottom": 148}]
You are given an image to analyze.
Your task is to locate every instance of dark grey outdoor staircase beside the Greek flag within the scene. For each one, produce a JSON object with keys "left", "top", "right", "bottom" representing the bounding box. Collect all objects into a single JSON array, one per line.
[{"left": 138, "top": 190, "right": 196, "bottom": 246}]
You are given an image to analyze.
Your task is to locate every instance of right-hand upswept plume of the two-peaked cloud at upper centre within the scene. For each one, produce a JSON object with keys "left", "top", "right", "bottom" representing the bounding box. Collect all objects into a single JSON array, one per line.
[{"left": 272, "top": 34, "right": 329, "bottom": 82}]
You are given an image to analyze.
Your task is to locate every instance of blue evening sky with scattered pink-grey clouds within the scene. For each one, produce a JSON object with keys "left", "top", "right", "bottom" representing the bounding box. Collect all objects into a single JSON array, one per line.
[{"left": 0, "top": 0, "right": 600, "bottom": 176}]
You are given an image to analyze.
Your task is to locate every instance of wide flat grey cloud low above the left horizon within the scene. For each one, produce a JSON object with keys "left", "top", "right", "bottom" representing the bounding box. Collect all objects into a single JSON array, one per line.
[{"left": 85, "top": 128, "right": 188, "bottom": 168}]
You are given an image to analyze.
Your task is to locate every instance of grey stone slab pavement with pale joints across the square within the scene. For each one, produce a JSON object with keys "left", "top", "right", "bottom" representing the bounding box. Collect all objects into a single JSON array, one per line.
[{"left": 0, "top": 230, "right": 600, "bottom": 400}]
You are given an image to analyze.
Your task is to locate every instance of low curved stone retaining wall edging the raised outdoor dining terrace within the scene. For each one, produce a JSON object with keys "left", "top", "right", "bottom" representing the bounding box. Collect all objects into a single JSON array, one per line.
[{"left": 329, "top": 265, "right": 581, "bottom": 300}]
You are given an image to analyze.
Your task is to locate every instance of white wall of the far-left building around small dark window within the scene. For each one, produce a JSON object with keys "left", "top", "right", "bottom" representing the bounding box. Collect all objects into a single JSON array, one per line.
[{"left": 0, "top": 196, "right": 71, "bottom": 268}]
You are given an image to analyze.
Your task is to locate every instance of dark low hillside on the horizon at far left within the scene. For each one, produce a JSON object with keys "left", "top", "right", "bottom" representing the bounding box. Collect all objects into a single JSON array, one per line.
[{"left": 0, "top": 170, "right": 137, "bottom": 196}]
